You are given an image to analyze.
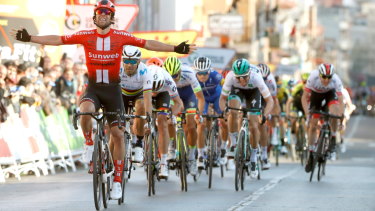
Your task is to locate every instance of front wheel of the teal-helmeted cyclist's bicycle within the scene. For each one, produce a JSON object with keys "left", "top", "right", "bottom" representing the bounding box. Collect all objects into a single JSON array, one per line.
[{"left": 234, "top": 131, "right": 245, "bottom": 191}]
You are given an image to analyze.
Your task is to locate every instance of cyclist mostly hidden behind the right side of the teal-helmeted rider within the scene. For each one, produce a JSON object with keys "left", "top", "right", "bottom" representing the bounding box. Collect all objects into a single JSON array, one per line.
[{"left": 258, "top": 63, "right": 281, "bottom": 170}]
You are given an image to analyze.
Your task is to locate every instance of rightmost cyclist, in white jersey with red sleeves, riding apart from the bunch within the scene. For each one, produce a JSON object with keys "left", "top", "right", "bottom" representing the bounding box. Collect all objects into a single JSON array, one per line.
[{"left": 302, "top": 64, "right": 343, "bottom": 172}]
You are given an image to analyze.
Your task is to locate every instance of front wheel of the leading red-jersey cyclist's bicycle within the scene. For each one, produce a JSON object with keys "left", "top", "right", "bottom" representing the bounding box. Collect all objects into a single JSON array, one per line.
[{"left": 92, "top": 136, "right": 102, "bottom": 210}]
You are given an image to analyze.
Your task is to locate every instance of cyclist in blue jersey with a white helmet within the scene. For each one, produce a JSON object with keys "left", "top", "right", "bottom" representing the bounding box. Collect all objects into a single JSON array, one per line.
[{"left": 194, "top": 57, "right": 228, "bottom": 168}]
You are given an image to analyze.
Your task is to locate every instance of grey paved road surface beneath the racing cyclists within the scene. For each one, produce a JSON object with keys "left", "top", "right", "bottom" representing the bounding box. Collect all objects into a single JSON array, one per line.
[{"left": 0, "top": 116, "right": 375, "bottom": 211}]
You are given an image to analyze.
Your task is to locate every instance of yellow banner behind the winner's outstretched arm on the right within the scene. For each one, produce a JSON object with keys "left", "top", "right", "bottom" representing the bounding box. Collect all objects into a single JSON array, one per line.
[{"left": 133, "top": 31, "right": 198, "bottom": 59}]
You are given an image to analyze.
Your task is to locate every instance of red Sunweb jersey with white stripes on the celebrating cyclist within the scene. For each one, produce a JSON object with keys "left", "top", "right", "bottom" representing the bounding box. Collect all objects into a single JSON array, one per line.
[{"left": 61, "top": 29, "right": 146, "bottom": 84}]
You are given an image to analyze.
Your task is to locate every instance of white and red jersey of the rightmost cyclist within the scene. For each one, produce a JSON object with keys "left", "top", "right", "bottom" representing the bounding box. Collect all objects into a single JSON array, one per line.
[{"left": 305, "top": 70, "right": 343, "bottom": 94}]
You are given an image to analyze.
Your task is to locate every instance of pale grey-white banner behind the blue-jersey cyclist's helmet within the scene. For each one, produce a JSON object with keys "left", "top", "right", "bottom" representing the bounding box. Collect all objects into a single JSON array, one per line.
[{"left": 181, "top": 48, "right": 236, "bottom": 69}]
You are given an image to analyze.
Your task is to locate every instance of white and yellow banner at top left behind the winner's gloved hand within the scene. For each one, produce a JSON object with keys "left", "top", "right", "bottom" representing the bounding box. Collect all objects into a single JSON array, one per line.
[{"left": 0, "top": 0, "right": 66, "bottom": 64}]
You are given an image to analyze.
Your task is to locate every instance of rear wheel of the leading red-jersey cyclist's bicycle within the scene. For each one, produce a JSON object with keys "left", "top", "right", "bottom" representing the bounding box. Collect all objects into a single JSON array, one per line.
[{"left": 102, "top": 141, "right": 113, "bottom": 208}]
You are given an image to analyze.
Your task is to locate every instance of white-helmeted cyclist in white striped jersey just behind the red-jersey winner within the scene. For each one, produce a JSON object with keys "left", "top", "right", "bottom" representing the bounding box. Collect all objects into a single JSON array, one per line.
[{"left": 120, "top": 45, "right": 153, "bottom": 162}]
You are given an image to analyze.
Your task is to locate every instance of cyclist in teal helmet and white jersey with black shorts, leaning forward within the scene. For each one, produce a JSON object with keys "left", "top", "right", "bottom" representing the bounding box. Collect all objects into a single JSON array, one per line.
[{"left": 220, "top": 59, "right": 274, "bottom": 178}]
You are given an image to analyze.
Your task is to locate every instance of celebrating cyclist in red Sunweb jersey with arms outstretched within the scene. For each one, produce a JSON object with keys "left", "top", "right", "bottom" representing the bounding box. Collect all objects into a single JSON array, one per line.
[{"left": 12, "top": 0, "right": 195, "bottom": 199}]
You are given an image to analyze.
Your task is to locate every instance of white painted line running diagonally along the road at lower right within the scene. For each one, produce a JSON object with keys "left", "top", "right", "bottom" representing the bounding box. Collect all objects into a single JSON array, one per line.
[{"left": 228, "top": 167, "right": 300, "bottom": 211}]
